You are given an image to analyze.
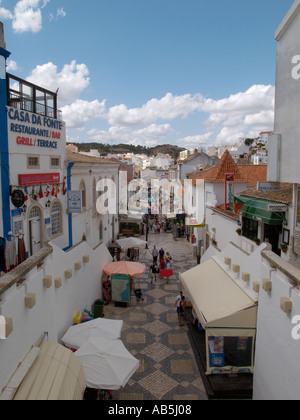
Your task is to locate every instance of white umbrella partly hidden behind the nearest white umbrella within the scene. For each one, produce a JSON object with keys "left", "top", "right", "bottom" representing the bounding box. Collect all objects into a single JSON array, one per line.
[{"left": 62, "top": 318, "right": 123, "bottom": 349}]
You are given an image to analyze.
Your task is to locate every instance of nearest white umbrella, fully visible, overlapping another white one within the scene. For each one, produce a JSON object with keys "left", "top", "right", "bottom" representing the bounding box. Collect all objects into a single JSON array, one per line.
[{"left": 74, "top": 338, "right": 139, "bottom": 390}]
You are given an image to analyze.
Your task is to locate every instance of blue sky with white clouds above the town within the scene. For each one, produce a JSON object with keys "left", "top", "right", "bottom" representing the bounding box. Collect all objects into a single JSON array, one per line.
[{"left": 0, "top": 0, "right": 293, "bottom": 148}]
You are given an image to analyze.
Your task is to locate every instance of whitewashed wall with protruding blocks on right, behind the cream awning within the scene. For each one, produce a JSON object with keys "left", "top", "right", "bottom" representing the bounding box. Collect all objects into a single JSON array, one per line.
[{"left": 201, "top": 243, "right": 300, "bottom": 400}]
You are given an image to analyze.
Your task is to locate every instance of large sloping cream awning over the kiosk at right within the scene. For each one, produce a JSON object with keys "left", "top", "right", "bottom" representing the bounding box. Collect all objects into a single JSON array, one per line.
[{"left": 180, "top": 258, "right": 257, "bottom": 328}]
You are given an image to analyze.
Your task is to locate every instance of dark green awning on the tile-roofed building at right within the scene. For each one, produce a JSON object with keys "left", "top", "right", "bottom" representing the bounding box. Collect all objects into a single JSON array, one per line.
[{"left": 233, "top": 197, "right": 286, "bottom": 225}]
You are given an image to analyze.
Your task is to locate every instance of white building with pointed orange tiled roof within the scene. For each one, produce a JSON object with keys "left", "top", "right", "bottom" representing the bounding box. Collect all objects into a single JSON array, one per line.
[{"left": 190, "top": 151, "right": 267, "bottom": 252}]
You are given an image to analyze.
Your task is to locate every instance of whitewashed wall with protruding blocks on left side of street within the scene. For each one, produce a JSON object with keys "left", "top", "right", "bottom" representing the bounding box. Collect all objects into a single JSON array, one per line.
[{"left": 0, "top": 242, "right": 111, "bottom": 390}]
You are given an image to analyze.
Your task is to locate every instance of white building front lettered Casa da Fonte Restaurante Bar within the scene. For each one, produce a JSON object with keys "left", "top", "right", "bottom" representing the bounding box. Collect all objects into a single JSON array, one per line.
[{"left": 3, "top": 75, "right": 68, "bottom": 262}]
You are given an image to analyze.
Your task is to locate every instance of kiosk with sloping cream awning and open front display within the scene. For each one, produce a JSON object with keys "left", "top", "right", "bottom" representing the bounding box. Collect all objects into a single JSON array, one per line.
[{"left": 180, "top": 259, "right": 257, "bottom": 375}]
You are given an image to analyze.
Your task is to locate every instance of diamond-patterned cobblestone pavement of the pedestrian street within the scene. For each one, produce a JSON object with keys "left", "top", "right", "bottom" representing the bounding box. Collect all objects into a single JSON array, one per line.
[{"left": 104, "top": 233, "right": 207, "bottom": 400}]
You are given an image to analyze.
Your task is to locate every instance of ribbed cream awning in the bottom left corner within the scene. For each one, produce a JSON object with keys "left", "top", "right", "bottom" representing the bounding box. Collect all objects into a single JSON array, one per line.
[{"left": 3, "top": 342, "right": 86, "bottom": 400}]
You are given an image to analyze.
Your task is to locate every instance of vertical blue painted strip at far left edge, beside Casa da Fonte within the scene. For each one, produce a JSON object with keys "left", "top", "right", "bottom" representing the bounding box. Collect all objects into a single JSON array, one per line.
[{"left": 0, "top": 48, "right": 11, "bottom": 238}]
